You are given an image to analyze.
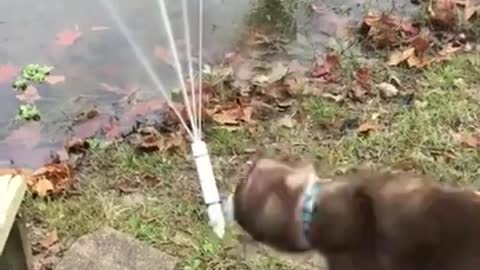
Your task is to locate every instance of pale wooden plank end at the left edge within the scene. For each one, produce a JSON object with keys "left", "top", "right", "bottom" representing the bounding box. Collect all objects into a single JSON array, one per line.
[{"left": 0, "top": 175, "right": 27, "bottom": 254}]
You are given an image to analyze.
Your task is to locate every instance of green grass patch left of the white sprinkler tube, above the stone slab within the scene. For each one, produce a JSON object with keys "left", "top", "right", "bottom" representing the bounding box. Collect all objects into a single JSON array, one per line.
[{"left": 23, "top": 142, "right": 288, "bottom": 270}]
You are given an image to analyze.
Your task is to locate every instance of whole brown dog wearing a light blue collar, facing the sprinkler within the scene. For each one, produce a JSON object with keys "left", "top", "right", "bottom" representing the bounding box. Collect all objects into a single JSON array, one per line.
[{"left": 225, "top": 159, "right": 480, "bottom": 270}]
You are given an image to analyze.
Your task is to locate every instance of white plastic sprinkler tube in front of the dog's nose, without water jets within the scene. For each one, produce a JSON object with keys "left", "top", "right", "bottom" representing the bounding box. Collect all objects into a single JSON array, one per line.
[{"left": 192, "top": 139, "right": 225, "bottom": 238}]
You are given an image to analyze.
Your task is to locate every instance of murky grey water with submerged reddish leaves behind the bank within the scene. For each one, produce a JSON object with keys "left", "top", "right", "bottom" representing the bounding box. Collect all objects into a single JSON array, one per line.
[{"left": 0, "top": 0, "right": 414, "bottom": 167}]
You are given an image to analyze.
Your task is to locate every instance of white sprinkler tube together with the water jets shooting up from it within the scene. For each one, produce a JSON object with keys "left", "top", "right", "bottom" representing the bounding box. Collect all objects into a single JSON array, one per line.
[{"left": 102, "top": 0, "right": 225, "bottom": 238}]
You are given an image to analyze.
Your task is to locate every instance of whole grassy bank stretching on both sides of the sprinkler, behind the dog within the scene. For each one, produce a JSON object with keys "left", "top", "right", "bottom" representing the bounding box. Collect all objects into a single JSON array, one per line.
[{"left": 22, "top": 53, "right": 480, "bottom": 269}]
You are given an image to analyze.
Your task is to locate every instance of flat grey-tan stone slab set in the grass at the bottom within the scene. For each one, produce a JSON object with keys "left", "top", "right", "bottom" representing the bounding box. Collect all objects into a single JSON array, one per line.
[{"left": 55, "top": 228, "right": 178, "bottom": 270}]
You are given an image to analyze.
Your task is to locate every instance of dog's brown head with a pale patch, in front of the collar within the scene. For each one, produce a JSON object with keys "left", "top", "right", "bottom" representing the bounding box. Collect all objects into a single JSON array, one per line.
[{"left": 223, "top": 159, "right": 317, "bottom": 252}]
